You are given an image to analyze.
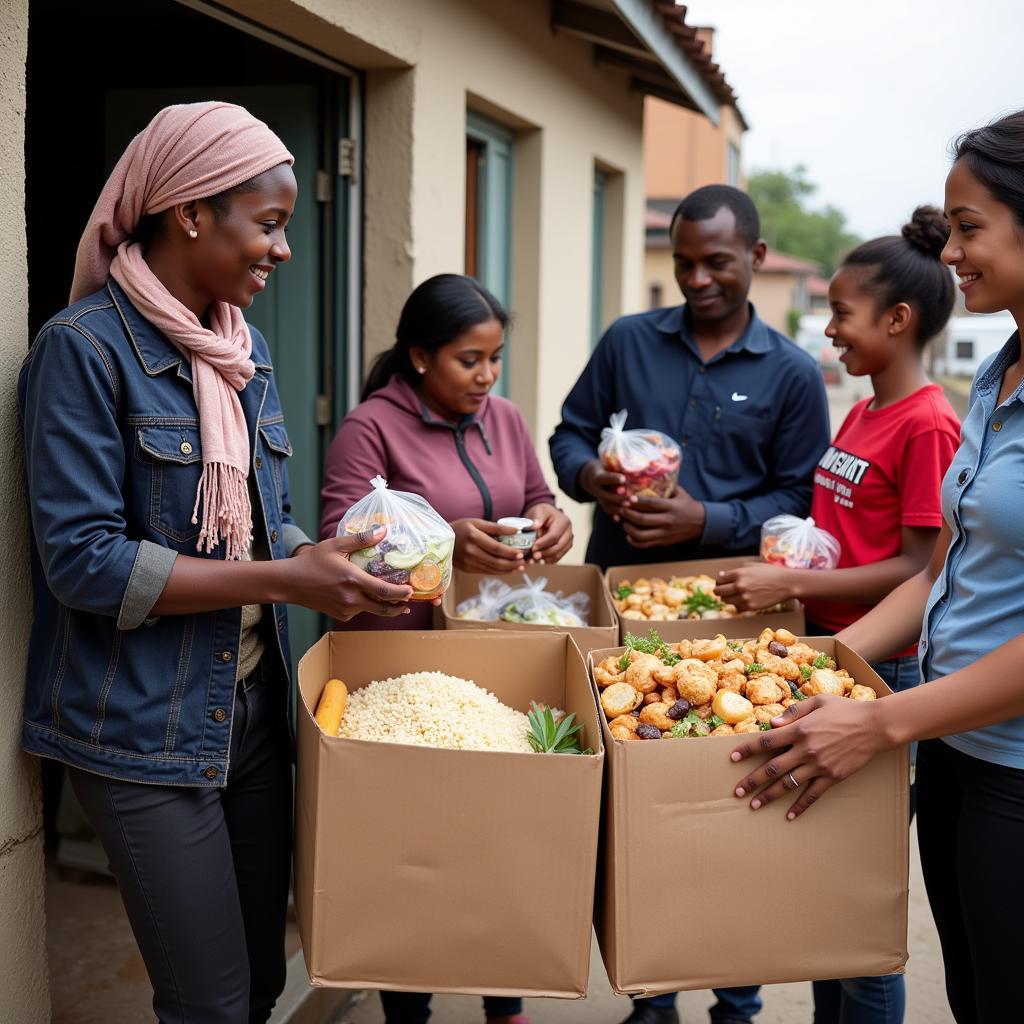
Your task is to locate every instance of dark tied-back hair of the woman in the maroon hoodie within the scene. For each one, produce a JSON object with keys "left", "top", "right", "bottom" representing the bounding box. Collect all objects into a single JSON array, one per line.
[{"left": 359, "top": 273, "right": 509, "bottom": 401}]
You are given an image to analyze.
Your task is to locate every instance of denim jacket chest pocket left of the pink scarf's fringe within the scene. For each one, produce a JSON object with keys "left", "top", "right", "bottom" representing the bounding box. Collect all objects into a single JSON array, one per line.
[{"left": 135, "top": 423, "right": 203, "bottom": 544}]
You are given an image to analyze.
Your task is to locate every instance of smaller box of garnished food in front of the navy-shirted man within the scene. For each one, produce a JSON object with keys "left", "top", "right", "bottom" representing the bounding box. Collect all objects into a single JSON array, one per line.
[{"left": 604, "top": 555, "right": 805, "bottom": 643}]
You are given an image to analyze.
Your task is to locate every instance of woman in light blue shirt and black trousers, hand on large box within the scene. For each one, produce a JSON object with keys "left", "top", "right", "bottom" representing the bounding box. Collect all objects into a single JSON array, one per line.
[{"left": 732, "top": 111, "right": 1024, "bottom": 1024}]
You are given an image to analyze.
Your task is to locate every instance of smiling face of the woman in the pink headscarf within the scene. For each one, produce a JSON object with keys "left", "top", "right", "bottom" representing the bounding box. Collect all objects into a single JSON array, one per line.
[{"left": 186, "top": 164, "right": 297, "bottom": 309}]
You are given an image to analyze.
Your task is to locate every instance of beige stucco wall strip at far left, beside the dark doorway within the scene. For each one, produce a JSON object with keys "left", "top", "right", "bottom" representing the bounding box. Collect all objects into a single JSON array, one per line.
[{"left": 0, "top": 0, "right": 50, "bottom": 1024}]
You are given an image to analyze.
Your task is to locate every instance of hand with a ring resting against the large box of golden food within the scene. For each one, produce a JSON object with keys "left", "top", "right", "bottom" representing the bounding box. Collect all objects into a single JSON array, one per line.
[{"left": 731, "top": 695, "right": 886, "bottom": 821}]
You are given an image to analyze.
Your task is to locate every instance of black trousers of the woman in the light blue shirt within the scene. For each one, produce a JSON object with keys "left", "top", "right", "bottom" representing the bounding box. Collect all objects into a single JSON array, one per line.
[{"left": 918, "top": 739, "right": 1024, "bottom": 1024}]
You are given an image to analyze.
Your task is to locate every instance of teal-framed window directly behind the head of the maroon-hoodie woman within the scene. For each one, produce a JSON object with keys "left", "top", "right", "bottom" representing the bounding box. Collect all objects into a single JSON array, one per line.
[{"left": 466, "top": 111, "right": 514, "bottom": 395}]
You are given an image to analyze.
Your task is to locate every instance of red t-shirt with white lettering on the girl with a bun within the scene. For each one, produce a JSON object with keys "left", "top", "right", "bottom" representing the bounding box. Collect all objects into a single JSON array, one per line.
[{"left": 806, "top": 384, "right": 959, "bottom": 654}]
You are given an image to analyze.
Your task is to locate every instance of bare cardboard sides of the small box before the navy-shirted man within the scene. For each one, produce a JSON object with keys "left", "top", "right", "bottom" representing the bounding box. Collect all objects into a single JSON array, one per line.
[{"left": 604, "top": 555, "right": 806, "bottom": 643}]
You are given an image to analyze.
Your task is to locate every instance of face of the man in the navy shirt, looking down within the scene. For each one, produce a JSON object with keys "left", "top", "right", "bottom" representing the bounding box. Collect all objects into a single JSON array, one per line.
[{"left": 672, "top": 206, "right": 765, "bottom": 324}]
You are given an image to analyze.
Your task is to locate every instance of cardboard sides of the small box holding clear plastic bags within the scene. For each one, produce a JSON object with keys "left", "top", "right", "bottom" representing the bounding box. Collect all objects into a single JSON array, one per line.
[{"left": 441, "top": 565, "right": 618, "bottom": 654}]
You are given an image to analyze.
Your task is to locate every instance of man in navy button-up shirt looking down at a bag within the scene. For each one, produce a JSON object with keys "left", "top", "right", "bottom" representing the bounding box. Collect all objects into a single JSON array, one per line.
[{"left": 550, "top": 185, "right": 829, "bottom": 581}]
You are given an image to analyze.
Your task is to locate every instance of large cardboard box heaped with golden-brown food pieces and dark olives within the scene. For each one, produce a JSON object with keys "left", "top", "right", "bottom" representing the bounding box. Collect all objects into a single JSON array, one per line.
[{"left": 590, "top": 630, "right": 909, "bottom": 995}]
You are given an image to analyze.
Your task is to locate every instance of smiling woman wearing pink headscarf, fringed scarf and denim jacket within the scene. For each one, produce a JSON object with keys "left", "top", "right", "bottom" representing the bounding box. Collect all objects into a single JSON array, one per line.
[{"left": 18, "top": 102, "right": 412, "bottom": 1024}]
